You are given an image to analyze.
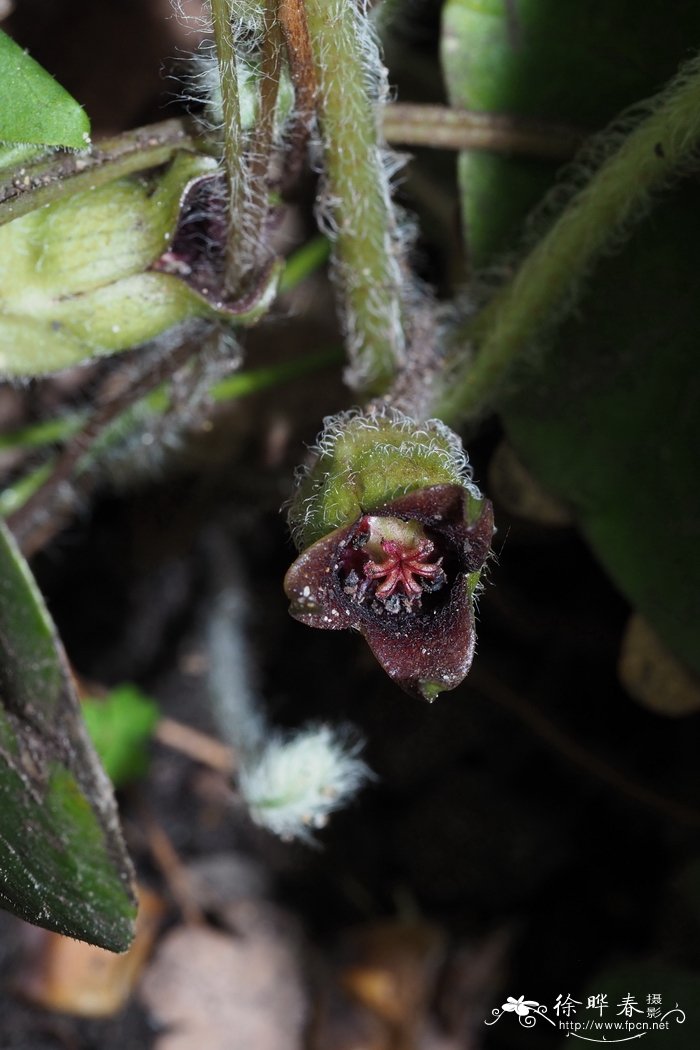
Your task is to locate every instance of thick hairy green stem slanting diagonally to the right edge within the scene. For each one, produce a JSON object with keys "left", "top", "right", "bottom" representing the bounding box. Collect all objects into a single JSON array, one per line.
[{"left": 436, "top": 59, "right": 700, "bottom": 421}]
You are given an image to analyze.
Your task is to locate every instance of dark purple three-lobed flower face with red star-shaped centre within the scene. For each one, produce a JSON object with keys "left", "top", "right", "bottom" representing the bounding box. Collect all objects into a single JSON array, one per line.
[{"left": 284, "top": 484, "right": 493, "bottom": 700}]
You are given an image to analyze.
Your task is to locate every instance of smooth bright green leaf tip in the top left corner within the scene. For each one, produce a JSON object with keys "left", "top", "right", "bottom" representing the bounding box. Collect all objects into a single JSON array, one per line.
[{"left": 0, "top": 30, "right": 90, "bottom": 149}]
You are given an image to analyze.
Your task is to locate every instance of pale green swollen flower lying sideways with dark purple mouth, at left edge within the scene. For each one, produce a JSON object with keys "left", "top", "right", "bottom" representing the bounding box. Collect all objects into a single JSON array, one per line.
[{"left": 0, "top": 152, "right": 279, "bottom": 376}]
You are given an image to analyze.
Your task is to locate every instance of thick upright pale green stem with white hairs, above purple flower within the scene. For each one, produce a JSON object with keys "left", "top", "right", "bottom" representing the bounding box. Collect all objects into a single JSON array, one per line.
[{"left": 305, "top": 0, "right": 405, "bottom": 392}]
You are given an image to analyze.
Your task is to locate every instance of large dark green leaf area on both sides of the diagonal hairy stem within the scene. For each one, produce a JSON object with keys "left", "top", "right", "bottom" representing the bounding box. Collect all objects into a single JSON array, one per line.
[{"left": 443, "top": 0, "right": 700, "bottom": 671}]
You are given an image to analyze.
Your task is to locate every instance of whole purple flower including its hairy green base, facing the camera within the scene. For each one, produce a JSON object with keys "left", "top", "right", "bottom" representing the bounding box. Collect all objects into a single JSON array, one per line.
[{"left": 284, "top": 410, "right": 493, "bottom": 700}]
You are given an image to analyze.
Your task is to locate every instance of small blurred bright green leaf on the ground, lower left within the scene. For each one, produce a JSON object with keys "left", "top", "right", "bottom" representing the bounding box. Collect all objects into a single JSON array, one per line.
[{"left": 82, "top": 686, "right": 160, "bottom": 788}]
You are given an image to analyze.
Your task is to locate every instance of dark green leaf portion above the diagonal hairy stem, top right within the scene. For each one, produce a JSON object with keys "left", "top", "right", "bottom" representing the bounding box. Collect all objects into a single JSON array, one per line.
[{"left": 442, "top": 0, "right": 700, "bottom": 268}]
